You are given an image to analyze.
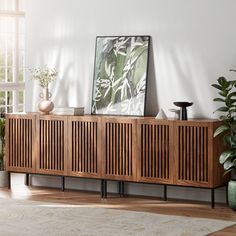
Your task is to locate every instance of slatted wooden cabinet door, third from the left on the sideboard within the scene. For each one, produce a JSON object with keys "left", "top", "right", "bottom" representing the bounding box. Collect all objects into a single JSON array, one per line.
[{"left": 68, "top": 116, "right": 101, "bottom": 178}]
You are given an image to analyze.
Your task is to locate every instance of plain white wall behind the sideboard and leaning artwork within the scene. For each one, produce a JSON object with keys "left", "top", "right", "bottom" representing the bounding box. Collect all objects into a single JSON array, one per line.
[{"left": 26, "top": 0, "right": 236, "bottom": 203}]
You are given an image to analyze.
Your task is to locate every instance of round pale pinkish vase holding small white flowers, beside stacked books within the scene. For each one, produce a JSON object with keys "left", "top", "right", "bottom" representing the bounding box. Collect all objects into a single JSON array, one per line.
[{"left": 38, "top": 87, "right": 54, "bottom": 115}]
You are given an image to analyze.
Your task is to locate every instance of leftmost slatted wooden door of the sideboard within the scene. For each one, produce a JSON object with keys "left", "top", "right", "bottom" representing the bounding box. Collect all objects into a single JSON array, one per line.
[{"left": 6, "top": 114, "right": 36, "bottom": 173}]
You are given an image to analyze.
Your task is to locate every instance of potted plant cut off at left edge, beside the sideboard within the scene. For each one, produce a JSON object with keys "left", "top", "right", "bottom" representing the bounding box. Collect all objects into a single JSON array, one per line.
[{"left": 0, "top": 116, "right": 8, "bottom": 187}]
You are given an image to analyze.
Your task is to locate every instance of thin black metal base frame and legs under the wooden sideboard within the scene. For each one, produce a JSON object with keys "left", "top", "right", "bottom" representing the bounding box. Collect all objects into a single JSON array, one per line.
[{"left": 8, "top": 172, "right": 225, "bottom": 208}]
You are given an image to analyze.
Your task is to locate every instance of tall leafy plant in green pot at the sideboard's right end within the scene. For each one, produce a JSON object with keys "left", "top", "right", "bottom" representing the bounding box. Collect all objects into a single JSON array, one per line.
[{"left": 212, "top": 70, "right": 236, "bottom": 210}]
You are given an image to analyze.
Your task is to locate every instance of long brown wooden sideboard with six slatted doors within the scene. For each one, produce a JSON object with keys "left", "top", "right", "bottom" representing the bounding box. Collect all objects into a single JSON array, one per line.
[{"left": 6, "top": 113, "right": 228, "bottom": 207}]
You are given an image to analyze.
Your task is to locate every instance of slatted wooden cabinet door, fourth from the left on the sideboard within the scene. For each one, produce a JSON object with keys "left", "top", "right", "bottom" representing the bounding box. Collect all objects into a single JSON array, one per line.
[{"left": 102, "top": 117, "right": 136, "bottom": 181}]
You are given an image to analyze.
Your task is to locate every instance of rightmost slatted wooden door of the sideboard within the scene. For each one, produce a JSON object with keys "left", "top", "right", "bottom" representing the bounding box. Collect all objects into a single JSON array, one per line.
[{"left": 174, "top": 121, "right": 218, "bottom": 187}]
